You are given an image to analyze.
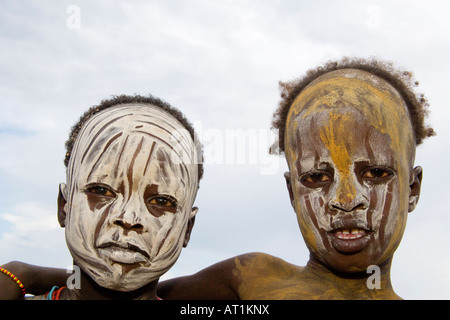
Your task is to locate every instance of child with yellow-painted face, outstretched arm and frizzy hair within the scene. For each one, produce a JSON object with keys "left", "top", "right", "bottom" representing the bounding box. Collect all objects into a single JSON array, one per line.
[{"left": 0, "top": 59, "right": 434, "bottom": 299}]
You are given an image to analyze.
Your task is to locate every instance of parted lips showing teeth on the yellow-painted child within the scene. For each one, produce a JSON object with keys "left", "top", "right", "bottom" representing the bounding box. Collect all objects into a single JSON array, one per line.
[{"left": 328, "top": 227, "right": 372, "bottom": 254}]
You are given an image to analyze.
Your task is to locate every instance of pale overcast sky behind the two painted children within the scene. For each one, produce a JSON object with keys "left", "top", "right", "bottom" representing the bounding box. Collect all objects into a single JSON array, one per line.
[{"left": 0, "top": 0, "right": 450, "bottom": 299}]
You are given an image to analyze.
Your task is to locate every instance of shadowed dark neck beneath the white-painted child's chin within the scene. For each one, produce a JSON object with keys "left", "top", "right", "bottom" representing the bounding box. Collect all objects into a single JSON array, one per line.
[{"left": 60, "top": 262, "right": 159, "bottom": 300}]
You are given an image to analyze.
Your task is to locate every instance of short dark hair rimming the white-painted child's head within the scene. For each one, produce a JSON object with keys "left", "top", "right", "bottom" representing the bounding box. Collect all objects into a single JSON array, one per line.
[{"left": 64, "top": 95, "right": 203, "bottom": 181}]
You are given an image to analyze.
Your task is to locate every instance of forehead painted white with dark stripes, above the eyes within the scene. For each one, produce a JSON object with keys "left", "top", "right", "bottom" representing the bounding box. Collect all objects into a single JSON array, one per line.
[{"left": 67, "top": 104, "right": 197, "bottom": 184}]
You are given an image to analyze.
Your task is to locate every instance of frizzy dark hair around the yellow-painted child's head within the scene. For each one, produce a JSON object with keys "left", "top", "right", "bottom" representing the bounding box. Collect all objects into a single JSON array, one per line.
[{"left": 270, "top": 57, "right": 435, "bottom": 153}]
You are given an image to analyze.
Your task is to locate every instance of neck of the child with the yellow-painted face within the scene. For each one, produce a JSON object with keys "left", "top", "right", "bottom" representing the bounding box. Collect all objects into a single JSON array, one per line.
[{"left": 305, "top": 255, "right": 401, "bottom": 300}]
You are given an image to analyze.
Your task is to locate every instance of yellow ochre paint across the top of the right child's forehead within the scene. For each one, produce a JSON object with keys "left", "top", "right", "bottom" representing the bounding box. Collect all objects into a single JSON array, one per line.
[{"left": 285, "top": 69, "right": 415, "bottom": 166}]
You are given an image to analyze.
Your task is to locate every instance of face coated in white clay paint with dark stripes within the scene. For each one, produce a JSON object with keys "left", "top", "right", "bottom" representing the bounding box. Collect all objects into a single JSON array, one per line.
[{"left": 61, "top": 104, "right": 198, "bottom": 291}]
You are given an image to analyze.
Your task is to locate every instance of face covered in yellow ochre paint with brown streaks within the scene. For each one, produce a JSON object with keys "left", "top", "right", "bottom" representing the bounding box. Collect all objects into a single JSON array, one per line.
[{"left": 285, "top": 69, "right": 415, "bottom": 271}]
